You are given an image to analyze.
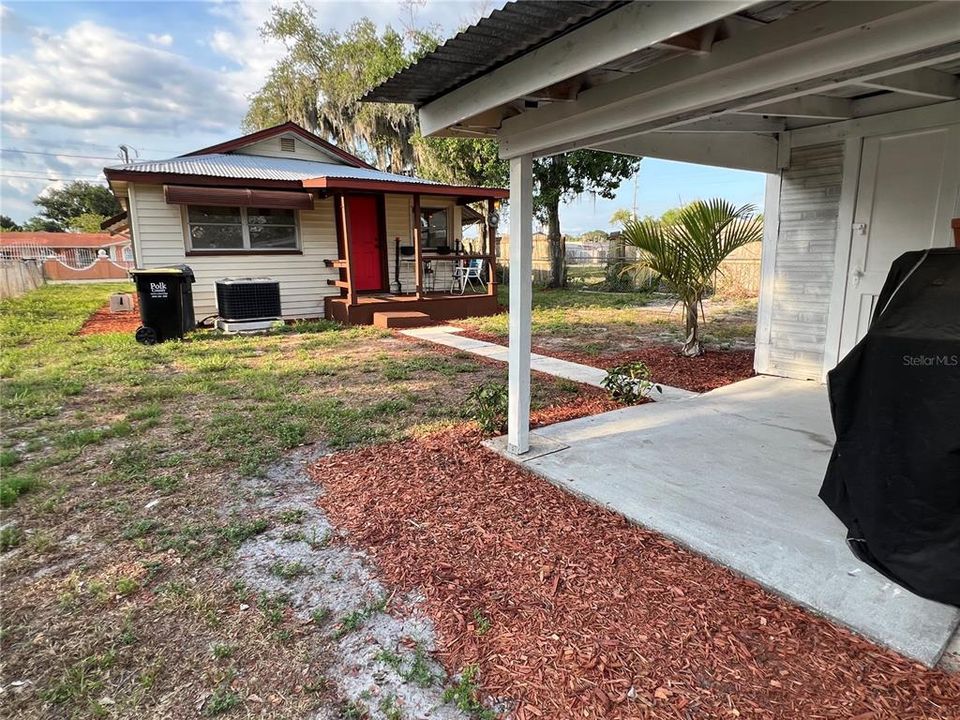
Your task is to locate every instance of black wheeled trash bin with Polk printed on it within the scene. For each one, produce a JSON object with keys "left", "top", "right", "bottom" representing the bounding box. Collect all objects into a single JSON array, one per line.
[{"left": 130, "top": 265, "right": 197, "bottom": 345}]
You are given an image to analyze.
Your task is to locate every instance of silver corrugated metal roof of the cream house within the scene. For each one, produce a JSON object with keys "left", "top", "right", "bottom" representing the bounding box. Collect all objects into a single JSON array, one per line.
[{"left": 107, "top": 153, "right": 442, "bottom": 185}]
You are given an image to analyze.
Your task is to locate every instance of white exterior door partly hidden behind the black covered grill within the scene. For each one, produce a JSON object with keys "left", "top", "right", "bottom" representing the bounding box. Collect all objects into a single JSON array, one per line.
[{"left": 839, "top": 125, "right": 960, "bottom": 358}]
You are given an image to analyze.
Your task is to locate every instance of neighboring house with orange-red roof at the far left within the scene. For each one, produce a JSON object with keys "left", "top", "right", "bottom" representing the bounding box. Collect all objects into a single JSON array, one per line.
[{"left": 0, "top": 232, "right": 133, "bottom": 267}]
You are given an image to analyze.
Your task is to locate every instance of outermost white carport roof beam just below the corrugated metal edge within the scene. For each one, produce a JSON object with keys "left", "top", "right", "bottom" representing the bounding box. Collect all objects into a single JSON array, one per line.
[{"left": 420, "top": 0, "right": 757, "bottom": 135}]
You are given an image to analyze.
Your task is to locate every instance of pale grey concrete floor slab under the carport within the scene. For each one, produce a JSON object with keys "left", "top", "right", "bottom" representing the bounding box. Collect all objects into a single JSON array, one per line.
[{"left": 492, "top": 376, "right": 960, "bottom": 666}]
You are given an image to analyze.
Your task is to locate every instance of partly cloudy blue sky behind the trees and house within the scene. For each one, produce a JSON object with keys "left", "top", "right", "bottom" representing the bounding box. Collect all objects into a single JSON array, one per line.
[{"left": 0, "top": 0, "right": 763, "bottom": 234}]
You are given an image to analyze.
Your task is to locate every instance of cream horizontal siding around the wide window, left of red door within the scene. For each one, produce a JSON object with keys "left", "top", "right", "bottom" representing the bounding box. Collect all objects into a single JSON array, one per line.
[{"left": 130, "top": 184, "right": 340, "bottom": 320}]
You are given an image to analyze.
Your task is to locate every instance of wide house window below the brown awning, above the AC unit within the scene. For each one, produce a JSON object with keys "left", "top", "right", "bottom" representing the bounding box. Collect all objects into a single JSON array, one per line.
[{"left": 187, "top": 205, "right": 299, "bottom": 252}]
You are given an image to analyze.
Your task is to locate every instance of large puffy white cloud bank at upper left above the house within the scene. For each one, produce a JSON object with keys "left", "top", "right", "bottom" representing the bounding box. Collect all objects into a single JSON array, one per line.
[{"left": 0, "top": 21, "right": 244, "bottom": 132}]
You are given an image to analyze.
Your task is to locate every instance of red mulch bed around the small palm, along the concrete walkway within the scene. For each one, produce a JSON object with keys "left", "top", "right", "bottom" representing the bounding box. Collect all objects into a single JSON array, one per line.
[{"left": 460, "top": 330, "right": 754, "bottom": 392}]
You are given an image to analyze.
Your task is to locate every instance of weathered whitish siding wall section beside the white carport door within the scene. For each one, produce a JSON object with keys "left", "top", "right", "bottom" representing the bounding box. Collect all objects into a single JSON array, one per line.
[{"left": 766, "top": 142, "right": 843, "bottom": 380}]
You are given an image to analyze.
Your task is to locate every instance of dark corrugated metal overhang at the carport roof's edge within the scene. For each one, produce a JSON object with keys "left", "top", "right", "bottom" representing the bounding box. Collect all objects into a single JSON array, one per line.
[{"left": 363, "top": 0, "right": 627, "bottom": 107}]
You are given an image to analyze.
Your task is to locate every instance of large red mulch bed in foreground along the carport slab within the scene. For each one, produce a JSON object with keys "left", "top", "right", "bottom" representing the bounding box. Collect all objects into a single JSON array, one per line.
[{"left": 313, "top": 429, "right": 960, "bottom": 720}]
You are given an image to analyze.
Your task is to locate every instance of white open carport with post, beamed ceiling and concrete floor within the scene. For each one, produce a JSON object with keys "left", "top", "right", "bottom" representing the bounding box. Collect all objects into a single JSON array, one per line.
[{"left": 365, "top": 0, "right": 960, "bottom": 664}]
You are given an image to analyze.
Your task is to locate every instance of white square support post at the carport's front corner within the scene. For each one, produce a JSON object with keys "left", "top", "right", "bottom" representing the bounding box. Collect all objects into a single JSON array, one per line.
[{"left": 507, "top": 155, "right": 533, "bottom": 455}]
